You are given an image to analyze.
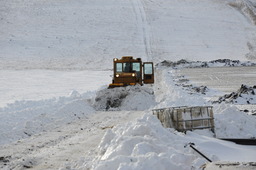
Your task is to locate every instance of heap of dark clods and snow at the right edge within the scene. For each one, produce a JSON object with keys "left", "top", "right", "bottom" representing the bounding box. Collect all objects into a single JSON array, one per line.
[{"left": 213, "top": 84, "right": 256, "bottom": 104}]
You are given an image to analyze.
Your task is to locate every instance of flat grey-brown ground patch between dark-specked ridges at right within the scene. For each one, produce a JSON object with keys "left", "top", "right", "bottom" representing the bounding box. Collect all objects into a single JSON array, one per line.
[{"left": 176, "top": 66, "right": 256, "bottom": 93}]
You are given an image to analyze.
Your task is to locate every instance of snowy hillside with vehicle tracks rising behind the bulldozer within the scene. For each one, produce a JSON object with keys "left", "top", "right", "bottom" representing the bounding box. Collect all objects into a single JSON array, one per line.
[{"left": 0, "top": 0, "right": 256, "bottom": 70}]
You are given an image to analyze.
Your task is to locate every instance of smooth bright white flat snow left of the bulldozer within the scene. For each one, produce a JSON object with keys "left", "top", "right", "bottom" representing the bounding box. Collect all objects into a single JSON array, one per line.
[{"left": 0, "top": 70, "right": 112, "bottom": 107}]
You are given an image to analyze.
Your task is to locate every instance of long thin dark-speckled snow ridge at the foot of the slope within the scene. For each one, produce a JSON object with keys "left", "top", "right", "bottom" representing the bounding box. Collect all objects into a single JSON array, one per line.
[{"left": 157, "top": 59, "right": 256, "bottom": 68}]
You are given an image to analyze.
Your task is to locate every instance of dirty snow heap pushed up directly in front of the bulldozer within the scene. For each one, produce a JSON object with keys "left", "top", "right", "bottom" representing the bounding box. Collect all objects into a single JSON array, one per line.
[{"left": 93, "top": 85, "right": 156, "bottom": 110}]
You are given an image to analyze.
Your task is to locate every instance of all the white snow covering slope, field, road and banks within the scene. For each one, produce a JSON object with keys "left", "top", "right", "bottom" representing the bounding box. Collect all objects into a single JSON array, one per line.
[{"left": 0, "top": 0, "right": 256, "bottom": 170}]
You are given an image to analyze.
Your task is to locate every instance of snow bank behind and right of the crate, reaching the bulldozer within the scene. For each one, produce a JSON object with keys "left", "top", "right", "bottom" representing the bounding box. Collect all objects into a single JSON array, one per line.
[{"left": 155, "top": 68, "right": 256, "bottom": 138}]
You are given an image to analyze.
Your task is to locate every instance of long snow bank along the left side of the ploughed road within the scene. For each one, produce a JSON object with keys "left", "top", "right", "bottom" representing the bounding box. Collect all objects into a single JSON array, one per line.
[{"left": 0, "top": 91, "right": 95, "bottom": 145}]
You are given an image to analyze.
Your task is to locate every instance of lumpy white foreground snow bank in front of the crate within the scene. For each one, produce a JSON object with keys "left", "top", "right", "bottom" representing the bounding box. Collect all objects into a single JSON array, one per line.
[{"left": 85, "top": 114, "right": 256, "bottom": 170}]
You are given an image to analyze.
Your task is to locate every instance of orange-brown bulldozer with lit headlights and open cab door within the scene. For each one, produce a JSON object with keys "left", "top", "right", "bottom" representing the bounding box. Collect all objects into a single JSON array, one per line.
[{"left": 108, "top": 56, "right": 154, "bottom": 88}]
